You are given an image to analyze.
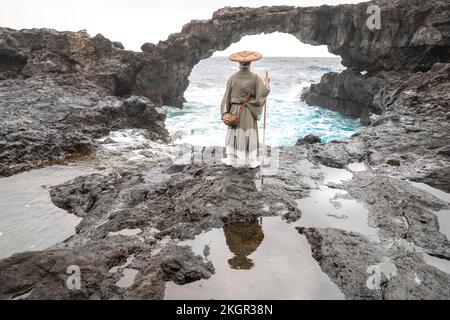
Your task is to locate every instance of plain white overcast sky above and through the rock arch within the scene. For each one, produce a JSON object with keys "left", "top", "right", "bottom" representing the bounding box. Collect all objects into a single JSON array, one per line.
[{"left": 0, "top": 0, "right": 361, "bottom": 57}]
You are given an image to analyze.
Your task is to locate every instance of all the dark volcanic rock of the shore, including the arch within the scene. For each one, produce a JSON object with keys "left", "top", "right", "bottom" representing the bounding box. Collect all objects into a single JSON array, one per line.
[{"left": 0, "top": 0, "right": 450, "bottom": 299}]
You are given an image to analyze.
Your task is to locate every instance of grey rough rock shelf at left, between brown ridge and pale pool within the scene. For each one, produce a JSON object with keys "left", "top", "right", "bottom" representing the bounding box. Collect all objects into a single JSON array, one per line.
[{"left": 0, "top": 78, "right": 168, "bottom": 176}]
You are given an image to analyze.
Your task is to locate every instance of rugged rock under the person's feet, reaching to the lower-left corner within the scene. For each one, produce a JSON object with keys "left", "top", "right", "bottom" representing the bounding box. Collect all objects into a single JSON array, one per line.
[{"left": 0, "top": 149, "right": 312, "bottom": 299}]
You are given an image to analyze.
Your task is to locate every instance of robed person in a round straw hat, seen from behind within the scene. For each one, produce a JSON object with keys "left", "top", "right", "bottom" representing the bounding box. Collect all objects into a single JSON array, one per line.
[{"left": 220, "top": 51, "right": 270, "bottom": 169}]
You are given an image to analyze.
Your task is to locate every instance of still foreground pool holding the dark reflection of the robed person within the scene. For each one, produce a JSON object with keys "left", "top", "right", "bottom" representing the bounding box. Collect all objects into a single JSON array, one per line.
[{"left": 165, "top": 217, "right": 344, "bottom": 300}]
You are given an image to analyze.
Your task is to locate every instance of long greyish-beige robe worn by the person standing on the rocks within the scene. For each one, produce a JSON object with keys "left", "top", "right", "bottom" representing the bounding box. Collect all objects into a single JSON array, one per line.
[{"left": 220, "top": 68, "right": 270, "bottom": 158}]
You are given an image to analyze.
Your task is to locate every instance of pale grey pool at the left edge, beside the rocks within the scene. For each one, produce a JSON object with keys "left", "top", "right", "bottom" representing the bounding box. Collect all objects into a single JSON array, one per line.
[{"left": 0, "top": 163, "right": 93, "bottom": 258}]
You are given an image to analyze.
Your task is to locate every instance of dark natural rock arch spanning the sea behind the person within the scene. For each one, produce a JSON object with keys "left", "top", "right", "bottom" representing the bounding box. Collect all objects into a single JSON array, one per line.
[{"left": 137, "top": 0, "right": 449, "bottom": 106}]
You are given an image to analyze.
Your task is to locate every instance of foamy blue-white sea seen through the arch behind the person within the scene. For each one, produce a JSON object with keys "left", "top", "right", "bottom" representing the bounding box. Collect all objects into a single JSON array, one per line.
[{"left": 166, "top": 57, "right": 361, "bottom": 146}]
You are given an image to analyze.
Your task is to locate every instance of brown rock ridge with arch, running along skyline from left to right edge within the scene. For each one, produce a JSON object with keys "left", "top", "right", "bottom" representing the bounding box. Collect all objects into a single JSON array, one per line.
[{"left": 0, "top": 0, "right": 450, "bottom": 106}]
